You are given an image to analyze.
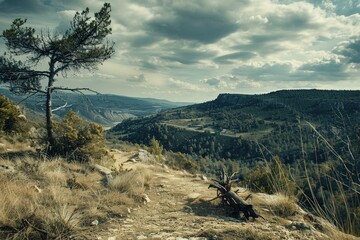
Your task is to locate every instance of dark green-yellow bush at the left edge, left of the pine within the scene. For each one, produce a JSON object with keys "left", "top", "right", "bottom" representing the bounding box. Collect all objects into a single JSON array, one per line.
[{"left": 0, "top": 95, "right": 26, "bottom": 134}]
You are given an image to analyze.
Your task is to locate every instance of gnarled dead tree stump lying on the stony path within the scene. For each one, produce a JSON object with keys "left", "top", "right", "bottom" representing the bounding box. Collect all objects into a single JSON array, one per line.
[{"left": 209, "top": 168, "right": 261, "bottom": 220}]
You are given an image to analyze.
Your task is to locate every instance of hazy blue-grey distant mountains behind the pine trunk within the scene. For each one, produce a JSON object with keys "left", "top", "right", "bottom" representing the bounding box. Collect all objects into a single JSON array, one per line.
[{"left": 0, "top": 88, "right": 189, "bottom": 127}]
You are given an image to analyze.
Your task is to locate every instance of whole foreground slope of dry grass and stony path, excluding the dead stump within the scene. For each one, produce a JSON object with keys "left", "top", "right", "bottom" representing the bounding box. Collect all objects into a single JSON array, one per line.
[{"left": 0, "top": 139, "right": 356, "bottom": 240}]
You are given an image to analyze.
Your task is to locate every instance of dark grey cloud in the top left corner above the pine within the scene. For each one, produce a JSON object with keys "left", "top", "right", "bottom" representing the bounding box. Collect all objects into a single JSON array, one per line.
[{"left": 0, "top": 0, "right": 49, "bottom": 13}]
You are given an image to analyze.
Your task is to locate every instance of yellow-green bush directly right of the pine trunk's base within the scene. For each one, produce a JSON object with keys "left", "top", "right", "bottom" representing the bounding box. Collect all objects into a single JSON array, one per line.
[{"left": 54, "top": 111, "right": 107, "bottom": 162}]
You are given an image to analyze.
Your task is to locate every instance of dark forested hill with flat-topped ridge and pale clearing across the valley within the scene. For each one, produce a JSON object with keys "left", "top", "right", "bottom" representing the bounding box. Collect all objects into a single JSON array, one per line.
[{"left": 110, "top": 90, "right": 360, "bottom": 165}]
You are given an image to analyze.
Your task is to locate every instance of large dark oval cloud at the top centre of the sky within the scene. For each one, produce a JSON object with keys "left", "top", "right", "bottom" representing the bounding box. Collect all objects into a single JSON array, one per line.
[{"left": 147, "top": 3, "right": 238, "bottom": 44}]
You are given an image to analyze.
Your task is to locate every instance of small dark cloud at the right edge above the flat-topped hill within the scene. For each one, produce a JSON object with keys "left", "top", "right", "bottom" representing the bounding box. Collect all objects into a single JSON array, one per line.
[{"left": 333, "top": 38, "right": 360, "bottom": 64}]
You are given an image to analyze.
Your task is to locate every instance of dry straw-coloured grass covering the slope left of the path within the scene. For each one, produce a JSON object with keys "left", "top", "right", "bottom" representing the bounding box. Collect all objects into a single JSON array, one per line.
[{"left": 0, "top": 150, "right": 151, "bottom": 239}]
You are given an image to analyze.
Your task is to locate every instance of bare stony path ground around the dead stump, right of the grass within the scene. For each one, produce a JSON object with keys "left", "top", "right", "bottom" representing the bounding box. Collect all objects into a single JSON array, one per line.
[{"left": 92, "top": 152, "right": 356, "bottom": 240}]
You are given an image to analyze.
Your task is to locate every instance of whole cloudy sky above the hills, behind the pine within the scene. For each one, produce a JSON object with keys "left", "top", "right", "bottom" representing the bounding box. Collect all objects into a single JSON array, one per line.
[{"left": 0, "top": 0, "right": 360, "bottom": 102}]
